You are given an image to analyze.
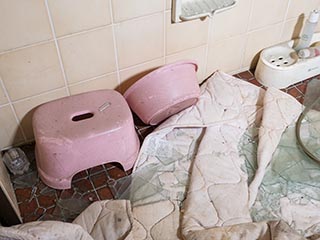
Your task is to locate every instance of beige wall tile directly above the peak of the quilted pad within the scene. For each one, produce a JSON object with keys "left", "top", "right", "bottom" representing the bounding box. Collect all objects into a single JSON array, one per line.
[{"left": 207, "top": 35, "right": 247, "bottom": 76}]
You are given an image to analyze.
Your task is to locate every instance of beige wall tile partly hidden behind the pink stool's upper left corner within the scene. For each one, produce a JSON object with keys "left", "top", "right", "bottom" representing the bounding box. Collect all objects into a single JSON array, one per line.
[{"left": 13, "top": 88, "right": 67, "bottom": 140}]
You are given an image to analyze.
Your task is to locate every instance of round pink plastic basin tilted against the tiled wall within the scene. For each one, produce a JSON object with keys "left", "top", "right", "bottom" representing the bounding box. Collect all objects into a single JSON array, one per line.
[{"left": 124, "top": 61, "right": 200, "bottom": 125}]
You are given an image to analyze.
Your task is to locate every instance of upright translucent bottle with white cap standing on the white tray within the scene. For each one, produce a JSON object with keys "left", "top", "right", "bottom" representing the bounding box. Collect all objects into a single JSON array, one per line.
[{"left": 294, "top": 10, "right": 319, "bottom": 51}]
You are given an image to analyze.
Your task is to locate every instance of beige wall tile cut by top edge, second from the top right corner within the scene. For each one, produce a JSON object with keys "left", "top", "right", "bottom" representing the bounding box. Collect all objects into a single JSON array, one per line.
[{"left": 249, "top": 0, "right": 288, "bottom": 30}]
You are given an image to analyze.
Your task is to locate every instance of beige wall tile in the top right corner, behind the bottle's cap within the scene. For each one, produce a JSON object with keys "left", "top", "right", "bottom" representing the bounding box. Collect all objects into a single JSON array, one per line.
[{"left": 287, "top": 0, "right": 320, "bottom": 19}]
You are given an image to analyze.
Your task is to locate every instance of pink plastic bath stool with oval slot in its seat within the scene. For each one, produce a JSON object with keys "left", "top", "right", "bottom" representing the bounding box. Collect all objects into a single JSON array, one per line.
[{"left": 33, "top": 90, "right": 139, "bottom": 189}]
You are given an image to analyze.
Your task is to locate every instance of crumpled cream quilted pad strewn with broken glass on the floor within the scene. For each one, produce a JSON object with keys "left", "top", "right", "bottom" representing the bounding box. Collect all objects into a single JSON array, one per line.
[{"left": 0, "top": 72, "right": 320, "bottom": 240}]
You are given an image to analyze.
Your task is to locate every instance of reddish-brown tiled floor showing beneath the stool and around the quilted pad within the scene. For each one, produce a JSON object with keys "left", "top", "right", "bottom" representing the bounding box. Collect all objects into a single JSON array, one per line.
[{"left": 12, "top": 71, "right": 316, "bottom": 222}]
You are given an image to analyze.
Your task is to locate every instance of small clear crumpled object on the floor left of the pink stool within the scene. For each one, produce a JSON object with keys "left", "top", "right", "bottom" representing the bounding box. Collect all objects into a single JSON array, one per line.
[{"left": 3, "top": 148, "right": 30, "bottom": 175}]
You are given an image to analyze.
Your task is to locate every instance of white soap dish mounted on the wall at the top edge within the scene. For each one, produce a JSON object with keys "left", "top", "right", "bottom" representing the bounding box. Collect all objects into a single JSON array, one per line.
[{"left": 172, "top": 0, "right": 236, "bottom": 23}]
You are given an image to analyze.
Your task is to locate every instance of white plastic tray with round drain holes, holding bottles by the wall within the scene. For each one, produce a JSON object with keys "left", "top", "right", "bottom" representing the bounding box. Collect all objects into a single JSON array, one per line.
[{"left": 255, "top": 33, "right": 320, "bottom": 89}]
